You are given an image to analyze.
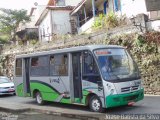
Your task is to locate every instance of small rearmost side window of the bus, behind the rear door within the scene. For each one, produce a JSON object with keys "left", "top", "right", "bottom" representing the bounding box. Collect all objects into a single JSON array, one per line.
[{"left": 15, "top": 59, "right": 22, "bottom": 76}]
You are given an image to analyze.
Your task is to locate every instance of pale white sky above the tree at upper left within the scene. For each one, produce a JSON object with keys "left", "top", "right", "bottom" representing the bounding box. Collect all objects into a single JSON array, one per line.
[{"left": 0, "top": 0, "right": 49, "bottom": 10}]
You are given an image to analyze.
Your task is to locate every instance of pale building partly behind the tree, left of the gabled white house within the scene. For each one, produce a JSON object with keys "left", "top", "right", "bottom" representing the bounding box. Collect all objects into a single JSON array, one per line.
[{"left": 16, "top": 7, "right": 38, "bottom": 45}]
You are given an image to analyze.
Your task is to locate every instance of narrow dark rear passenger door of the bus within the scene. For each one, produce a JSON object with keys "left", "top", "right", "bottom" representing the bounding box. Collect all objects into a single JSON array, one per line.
[{"left": 23, "top": 58, "right": 30, "bottom": 96}]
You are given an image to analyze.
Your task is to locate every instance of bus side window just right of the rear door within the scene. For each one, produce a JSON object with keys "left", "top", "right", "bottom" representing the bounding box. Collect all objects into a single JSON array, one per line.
[{"left": 30, "top": 56, "right": 49, "bottom": 76}]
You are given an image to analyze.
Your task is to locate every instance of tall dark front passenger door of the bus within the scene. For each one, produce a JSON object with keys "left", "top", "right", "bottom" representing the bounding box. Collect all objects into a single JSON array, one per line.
[{"left": 72, "top": 52, "right": 82, "bottom": 103}]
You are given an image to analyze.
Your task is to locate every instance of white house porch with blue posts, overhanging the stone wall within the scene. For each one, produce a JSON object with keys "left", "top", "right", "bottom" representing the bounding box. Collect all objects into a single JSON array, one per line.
[{"left": 71, "top": 0, "right": 121, "bottom": 33}]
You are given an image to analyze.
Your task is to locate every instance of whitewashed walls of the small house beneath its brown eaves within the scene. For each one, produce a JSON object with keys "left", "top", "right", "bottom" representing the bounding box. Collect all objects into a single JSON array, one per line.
[{"left": 39, "top": 10, "right": 71, "bottom": 42}]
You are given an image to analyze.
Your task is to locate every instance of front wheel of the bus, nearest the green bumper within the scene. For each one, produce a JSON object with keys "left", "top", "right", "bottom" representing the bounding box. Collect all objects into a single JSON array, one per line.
[{"left": 89, "top": 95, "right": 105, "bottom": 113}]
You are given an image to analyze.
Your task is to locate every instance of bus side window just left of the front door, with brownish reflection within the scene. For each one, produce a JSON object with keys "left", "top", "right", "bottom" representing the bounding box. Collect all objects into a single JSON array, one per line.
[{"left": 50, "top": 54, "right": 68, "bottom": 76}]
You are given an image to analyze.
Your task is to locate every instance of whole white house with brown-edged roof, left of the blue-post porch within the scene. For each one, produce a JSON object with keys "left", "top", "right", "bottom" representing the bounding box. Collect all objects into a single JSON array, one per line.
[{"left": 35, "top": 0, "right": 81, "bottom": 42}]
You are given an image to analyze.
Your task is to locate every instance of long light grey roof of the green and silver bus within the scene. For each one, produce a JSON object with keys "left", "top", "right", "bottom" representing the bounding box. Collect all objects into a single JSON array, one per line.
[{"left": 16, "top": 45, "right": 124, "bottom": 58}]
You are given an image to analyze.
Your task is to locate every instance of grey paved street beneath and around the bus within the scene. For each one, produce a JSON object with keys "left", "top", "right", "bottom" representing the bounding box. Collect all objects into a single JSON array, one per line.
[{"left": 0, "top": 95, "right": 160, "bottom": 119}]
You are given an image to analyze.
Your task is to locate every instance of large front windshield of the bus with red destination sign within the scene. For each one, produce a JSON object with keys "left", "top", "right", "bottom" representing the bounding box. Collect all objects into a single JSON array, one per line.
[{"left": 94, "top": 49, "right": 140, "bottom": 81}]
